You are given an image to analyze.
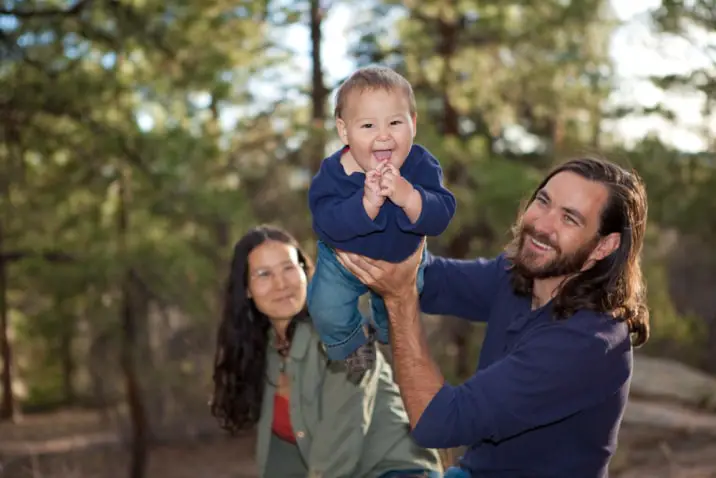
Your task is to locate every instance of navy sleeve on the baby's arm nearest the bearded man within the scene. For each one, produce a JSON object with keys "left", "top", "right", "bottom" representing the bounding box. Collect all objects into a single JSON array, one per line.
[{"left": 397, "top": 155, "right": 457, "bottom": 236}]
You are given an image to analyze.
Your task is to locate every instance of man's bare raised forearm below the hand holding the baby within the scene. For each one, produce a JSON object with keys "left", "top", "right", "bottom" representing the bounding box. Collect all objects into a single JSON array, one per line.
[{"left": 385, "top": 294, "right": 445, "bottom": 427}]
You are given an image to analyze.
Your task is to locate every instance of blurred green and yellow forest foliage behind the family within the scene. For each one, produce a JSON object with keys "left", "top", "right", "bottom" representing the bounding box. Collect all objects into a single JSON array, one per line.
[{"left": 0, "top": 0, "right": 716, "bottom": 414}]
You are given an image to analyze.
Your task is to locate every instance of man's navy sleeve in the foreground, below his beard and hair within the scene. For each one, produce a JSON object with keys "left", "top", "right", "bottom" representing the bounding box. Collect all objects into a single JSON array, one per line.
[{"left": 413, "top": 319, "right": 631, "bottom": 448}]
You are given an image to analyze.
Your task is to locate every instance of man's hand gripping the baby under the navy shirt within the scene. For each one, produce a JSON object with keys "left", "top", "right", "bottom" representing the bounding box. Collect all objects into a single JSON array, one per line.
[{"left": 336, "top": 239, "right": 425, "bottom": 302}]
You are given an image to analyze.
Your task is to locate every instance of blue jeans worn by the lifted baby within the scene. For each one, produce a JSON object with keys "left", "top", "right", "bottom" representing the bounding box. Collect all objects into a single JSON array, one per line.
[{"left": 307, "top": 241, "right": 427, "bottom": 360}]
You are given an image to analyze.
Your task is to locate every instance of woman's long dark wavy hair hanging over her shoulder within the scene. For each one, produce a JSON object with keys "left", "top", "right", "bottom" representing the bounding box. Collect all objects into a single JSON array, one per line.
[{"left": 210, "top": 225, "right": 313, "bottom": 433}]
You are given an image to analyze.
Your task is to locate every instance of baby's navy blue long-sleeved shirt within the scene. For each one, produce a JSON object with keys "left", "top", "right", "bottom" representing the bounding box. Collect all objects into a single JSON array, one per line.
[{"left": 308, "top": 145, "right": 456, "bottom": 262}]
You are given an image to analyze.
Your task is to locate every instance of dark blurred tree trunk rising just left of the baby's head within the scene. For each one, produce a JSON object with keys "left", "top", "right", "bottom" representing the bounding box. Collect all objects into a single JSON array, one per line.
[{"left": 308, "top": 0, "right": 328, "bottom": 174}]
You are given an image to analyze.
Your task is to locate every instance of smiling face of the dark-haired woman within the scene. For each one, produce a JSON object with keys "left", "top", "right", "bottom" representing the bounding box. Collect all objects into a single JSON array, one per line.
[{"left": 247, "top": 240, "right": 307, "bottom": 322}]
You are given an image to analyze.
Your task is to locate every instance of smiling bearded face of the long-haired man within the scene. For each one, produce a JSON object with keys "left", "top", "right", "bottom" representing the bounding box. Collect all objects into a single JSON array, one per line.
[{"left": 515, "top": 171, "right": 609, "bottom": 279}]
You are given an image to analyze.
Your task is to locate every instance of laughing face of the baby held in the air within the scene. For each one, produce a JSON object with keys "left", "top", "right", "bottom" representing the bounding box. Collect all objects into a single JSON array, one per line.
[{"left": 336, "top": 88, "right": 415, "bottom": 172}]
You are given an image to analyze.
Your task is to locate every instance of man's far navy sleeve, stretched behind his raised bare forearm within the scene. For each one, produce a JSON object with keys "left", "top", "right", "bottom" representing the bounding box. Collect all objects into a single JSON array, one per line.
[{"left": 420, "top": 254, "right": 507, "bottom": 322}]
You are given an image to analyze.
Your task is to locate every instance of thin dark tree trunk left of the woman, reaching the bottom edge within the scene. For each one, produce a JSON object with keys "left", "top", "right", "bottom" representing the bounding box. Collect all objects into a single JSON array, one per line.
[{"left": 117, "top": 168, "right": 150, "bottom": 478}]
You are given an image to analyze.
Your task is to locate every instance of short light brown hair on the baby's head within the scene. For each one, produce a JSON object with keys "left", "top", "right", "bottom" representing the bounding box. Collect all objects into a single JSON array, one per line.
[{"left": 334, "top": 65, "right": 417, "bottom": 118}]
